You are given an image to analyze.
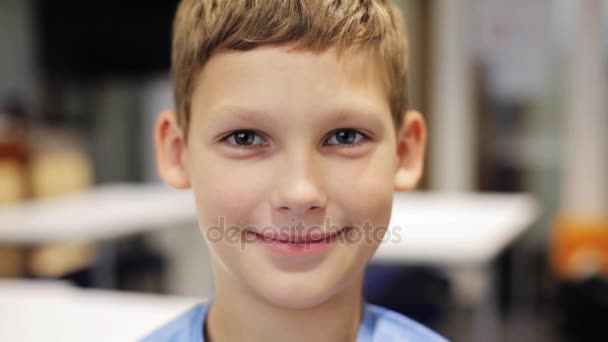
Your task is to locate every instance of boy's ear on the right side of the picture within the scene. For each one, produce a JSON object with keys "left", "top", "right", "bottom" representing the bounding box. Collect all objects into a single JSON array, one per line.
[{"left": 395, "top": 111, "right": 426, "bottom": 191}]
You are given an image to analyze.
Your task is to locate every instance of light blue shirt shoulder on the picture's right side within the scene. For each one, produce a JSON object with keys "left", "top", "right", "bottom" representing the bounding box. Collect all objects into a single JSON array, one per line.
[{"left": 357, "top": 303, "right": 447, "bottom": 342}]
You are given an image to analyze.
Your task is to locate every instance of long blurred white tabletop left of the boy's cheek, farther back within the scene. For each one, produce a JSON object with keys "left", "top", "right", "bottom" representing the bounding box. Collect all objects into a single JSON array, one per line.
[{"left": 0, "top": 184, "right": 196, "bottom": 244}]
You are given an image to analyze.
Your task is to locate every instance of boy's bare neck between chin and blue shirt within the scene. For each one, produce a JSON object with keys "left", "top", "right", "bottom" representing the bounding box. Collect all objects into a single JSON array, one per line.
[{"left": 206, "top": 268, "right": 363, "bottom": 342}]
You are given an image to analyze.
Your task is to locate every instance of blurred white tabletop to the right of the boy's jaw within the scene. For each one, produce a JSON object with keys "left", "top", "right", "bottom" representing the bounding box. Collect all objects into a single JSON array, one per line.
[{"left": 374, "top": 192, "right": 538, "bottom": 266}]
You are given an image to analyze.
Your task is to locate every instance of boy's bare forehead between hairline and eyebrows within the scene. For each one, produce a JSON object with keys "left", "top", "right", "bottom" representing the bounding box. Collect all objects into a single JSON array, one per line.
[{"left": 191, "top": 46, "right": 390, "bottom": 125}]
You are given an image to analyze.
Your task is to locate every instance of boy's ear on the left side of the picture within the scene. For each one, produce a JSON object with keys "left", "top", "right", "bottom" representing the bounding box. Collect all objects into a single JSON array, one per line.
[{"left": 154, "top": 110, "right": 190, "bottom": 189}]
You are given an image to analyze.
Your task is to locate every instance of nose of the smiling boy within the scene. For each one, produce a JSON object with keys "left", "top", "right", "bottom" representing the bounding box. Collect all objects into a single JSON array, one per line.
[{"left": 272, "top": 152, "right": 326, "bottom": 216}]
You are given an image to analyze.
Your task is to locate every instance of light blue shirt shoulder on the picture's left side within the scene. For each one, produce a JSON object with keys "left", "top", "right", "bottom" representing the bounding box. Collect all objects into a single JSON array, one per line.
[{"left": 140, "top": 303, "right": 208, "bottom": 342}]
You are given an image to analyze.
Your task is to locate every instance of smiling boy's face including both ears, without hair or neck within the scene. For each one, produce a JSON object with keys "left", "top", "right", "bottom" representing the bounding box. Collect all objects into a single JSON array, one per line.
[{"left": 156, "top": 47, "right": 425, "bottom": 308}]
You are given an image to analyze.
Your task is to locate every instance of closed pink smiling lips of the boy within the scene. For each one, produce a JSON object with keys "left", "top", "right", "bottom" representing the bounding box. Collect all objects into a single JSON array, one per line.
[{"left": 251, "top": 226, "right": 352, "bottom": 257}]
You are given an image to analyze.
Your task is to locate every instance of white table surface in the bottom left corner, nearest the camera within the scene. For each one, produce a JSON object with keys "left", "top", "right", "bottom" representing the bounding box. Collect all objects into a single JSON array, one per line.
[{"left": 0, "top": 279, "right": 204, "bottom": 342}]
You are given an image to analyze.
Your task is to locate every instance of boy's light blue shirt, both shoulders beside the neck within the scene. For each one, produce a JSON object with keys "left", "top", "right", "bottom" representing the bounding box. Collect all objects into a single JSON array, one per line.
[{"left": 142, "top": 301, "right": 447, "bottom": 342}]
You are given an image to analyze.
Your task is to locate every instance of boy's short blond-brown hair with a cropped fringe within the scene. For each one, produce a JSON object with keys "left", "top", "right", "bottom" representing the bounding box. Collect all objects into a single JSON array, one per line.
[{"left": 171, "top": 0, "right": 408, "bottom": 139}]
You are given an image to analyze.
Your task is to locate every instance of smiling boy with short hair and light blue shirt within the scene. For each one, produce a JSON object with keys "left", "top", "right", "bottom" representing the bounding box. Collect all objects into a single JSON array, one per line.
[{"left": 146, "top": 0, "right": 444, "bottom": 342}]
